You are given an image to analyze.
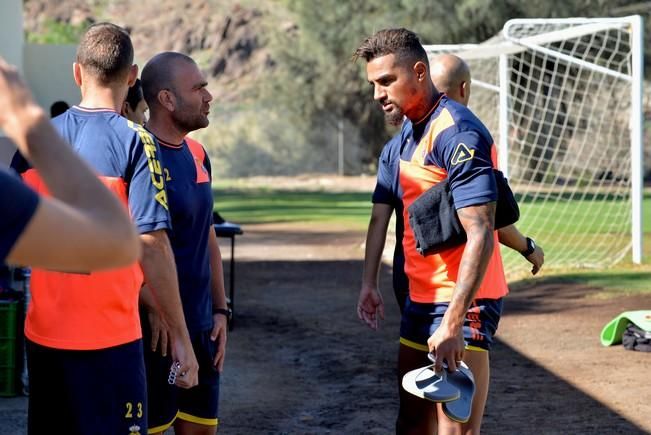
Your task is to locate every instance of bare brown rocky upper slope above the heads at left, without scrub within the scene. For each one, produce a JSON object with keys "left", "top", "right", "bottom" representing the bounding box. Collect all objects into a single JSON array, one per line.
[{"left": 24, "top": 0, "right": 273, "bottom": 101}]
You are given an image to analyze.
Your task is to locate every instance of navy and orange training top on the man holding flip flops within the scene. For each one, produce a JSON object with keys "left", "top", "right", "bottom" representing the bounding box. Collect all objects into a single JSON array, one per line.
[{"left": 396, "top": 94, "right": 508, "bottom": 303}]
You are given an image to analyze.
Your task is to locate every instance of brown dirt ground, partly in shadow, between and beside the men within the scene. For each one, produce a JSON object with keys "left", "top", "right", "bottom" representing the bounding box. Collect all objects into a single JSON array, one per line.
[{"left": 220, "top": 224, "right": 651, "bottom": 434}]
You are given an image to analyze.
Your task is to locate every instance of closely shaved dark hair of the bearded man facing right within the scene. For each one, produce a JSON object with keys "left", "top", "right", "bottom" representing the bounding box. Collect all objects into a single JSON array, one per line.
[{"left": 145, "top": 51, "right": 196, "bottom": 111}]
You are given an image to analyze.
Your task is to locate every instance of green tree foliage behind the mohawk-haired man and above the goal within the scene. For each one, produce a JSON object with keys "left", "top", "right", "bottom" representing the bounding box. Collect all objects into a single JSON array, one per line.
[{"left": 266, "top": 0, "right": 648, "bottom": 169}]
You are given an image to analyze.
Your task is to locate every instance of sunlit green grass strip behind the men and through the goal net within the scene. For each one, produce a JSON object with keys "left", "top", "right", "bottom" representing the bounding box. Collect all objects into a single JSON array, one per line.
[{"left": 215, "top": 186, "right": 651, "bottom": 297}]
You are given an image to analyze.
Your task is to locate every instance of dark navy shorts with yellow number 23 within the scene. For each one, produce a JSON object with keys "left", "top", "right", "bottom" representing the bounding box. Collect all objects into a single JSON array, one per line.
[{"left": 26, "top": 340, "right": 147, "bottom": 435}]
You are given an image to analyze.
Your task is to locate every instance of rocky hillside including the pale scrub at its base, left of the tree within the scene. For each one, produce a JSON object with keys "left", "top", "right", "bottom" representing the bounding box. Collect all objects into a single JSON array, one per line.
[{"left": 24, "top": 0, "right": 360, "bottom": 176}]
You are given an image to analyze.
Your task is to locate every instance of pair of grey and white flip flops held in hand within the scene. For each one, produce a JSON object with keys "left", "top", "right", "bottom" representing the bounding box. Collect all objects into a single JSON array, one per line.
[{"left": 402, "top": 356, "right": 475, "bottom": 423}]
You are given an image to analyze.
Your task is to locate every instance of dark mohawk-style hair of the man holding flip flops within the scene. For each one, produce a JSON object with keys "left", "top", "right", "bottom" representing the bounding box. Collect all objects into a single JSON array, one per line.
[{"left": 353, "top": 28, "right": 429, "bottom": 65}]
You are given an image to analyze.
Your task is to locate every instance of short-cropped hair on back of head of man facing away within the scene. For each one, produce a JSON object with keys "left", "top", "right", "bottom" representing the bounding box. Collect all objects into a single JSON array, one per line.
[{"left": 77, "top": 23, "right": 133, "bottom": 85}]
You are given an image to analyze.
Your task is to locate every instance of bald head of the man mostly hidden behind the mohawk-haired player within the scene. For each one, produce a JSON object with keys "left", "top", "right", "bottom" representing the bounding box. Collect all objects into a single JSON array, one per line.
[{"left": 430, "top": 54, "right": 471, "bottom": 106}]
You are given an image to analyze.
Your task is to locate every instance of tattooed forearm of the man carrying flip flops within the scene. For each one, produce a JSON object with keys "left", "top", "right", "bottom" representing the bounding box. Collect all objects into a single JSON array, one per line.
[{"left": 452, "top": 202, "right": 495, "bottom": 312}]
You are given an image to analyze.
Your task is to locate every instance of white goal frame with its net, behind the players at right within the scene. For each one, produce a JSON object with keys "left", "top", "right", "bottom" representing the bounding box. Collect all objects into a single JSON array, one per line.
[{"left": 425, "top": 16, "right": 643, "bottom": 275}]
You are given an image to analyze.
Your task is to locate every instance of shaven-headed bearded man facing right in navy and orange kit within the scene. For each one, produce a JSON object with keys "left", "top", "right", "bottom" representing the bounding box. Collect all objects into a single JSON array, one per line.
[{"left": 141, "top": 52, "right": 229, "bottom": 435}]
